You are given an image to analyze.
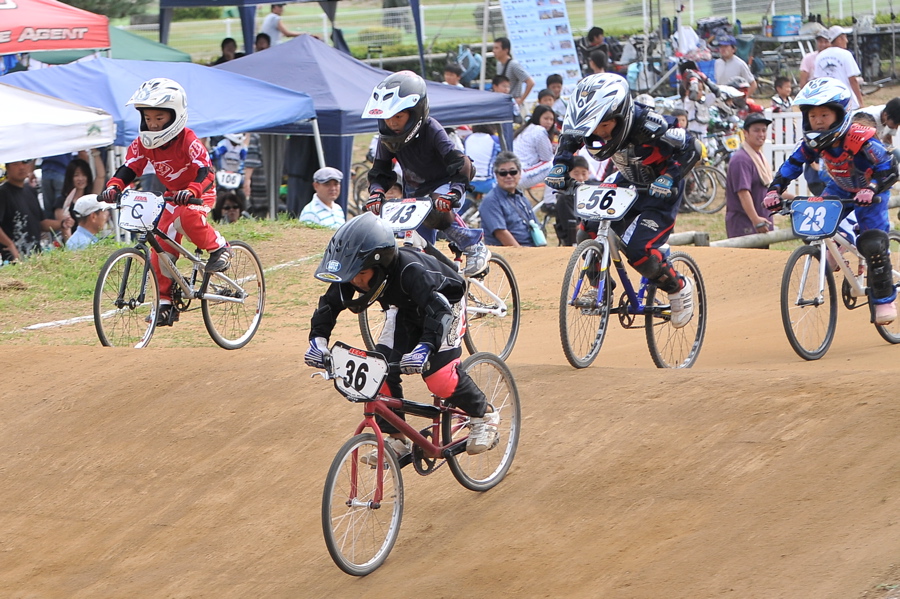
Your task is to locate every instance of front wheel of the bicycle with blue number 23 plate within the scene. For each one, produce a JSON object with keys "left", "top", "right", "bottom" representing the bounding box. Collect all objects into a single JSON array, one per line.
[{"left": 781, "top": 245, "right": 837, "bottom": 360}]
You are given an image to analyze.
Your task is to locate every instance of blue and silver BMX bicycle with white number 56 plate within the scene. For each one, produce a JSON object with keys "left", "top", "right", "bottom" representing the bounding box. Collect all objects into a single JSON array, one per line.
[{"left": 559, "top": 183, "right": 707, "bottom": 368}]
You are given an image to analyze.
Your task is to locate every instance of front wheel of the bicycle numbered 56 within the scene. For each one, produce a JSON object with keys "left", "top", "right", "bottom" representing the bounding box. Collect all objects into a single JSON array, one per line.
[{"left": 559, "top": 239, "right": 612, "bottom": 368}]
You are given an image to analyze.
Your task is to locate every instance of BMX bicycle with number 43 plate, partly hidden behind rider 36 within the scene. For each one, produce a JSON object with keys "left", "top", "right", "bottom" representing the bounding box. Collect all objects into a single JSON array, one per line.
[{"left": 359, "top": 197, "right": 522, "bottom": 360}]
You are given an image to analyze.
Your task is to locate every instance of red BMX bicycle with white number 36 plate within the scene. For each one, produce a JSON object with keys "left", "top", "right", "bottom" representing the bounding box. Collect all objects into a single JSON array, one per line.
[{"left": 312, "top": 341, "right": 521, "bottom": 576}]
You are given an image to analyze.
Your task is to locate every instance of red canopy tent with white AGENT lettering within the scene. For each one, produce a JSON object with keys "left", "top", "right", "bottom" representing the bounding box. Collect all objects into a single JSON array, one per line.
[{"left": 0, "top": 0, "right": 109, "bottom": 55}]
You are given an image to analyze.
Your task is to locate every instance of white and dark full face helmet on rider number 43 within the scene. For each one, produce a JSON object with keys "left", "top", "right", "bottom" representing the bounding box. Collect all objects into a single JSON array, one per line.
[{"left": 362, "top": 71, "right": 428, "bottom": 154}]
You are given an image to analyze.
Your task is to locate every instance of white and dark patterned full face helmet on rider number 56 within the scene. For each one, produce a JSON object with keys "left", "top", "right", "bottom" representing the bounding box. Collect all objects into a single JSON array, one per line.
[{"left": 563, "top": 73, "right": 634, "bottom": 160}]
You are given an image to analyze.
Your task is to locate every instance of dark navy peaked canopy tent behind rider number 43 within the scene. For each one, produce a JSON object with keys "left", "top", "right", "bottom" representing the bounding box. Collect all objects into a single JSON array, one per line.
[{"left": 214, "top": 35, "right": 513, "bottom": 212}]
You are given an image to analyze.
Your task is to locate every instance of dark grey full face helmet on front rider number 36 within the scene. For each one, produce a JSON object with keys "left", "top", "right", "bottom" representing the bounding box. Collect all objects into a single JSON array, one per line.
[{"left": 315, "top": 212, "right": 397, "bottom": 314}]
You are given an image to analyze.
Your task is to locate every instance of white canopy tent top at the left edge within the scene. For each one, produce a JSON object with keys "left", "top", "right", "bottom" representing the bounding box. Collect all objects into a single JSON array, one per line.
[{"left": 0, "top": 83, "right": 116, "bottom": 162}]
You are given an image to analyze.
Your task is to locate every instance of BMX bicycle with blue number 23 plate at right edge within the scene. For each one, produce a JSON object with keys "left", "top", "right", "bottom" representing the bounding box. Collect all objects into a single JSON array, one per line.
[{"left": 780, "top": 197, "right": 900, "bottom": 360}]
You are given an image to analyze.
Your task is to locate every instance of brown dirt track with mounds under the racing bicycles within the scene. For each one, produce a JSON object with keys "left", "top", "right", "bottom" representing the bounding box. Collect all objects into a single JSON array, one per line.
[{"left": 0, "top": 240, "right": 900, "bottom": 599}]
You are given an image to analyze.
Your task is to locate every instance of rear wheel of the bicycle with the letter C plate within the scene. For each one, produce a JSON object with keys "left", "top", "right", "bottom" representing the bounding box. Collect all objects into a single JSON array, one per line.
[{"left": 200, "top": 241, "right": 266, "bottom": 349}]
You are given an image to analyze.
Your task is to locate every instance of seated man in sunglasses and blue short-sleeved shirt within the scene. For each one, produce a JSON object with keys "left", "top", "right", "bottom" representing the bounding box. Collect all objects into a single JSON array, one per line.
[{"left": 478, "top": 152, "right": 537, "bottom": 247}]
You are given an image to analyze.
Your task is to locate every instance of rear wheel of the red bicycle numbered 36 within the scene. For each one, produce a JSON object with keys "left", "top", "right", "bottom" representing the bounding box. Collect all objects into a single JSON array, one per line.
[{"left": 441, "top": 352, "right": 522, "bottom": 492}]
